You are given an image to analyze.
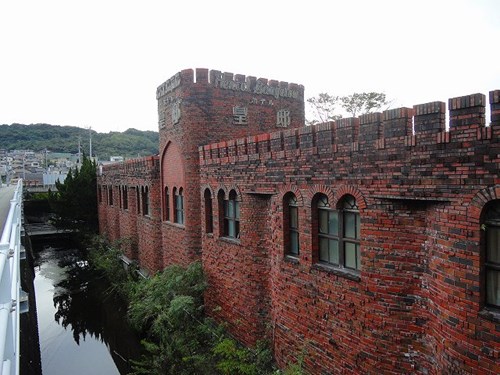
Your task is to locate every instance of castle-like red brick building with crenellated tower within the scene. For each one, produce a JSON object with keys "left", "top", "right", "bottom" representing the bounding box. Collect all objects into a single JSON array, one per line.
[{"left": 98, "top": 69, "right": 500, "bottom": 374}]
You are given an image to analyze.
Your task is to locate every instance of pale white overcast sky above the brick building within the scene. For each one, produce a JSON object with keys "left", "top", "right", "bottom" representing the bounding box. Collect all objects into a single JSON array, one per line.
[{"left": 0, "top": 0, "right": 500, "bottom": 132}]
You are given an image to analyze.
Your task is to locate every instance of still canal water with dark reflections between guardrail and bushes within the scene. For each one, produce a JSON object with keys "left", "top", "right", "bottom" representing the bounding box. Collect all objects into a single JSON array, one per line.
[{"left": 33, "top": 241, "right": 141, "bottom": 375}]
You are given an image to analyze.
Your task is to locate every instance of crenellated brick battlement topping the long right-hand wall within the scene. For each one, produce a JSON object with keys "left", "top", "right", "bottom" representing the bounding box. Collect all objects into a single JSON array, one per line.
[{"left": 199, "top": 90, "right": 500, "bottom": 164}]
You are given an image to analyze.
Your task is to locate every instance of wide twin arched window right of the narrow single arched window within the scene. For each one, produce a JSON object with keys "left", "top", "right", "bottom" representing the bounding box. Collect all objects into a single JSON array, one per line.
[{"left": 316, "top": 194, "right": 361, "bottom": 270}]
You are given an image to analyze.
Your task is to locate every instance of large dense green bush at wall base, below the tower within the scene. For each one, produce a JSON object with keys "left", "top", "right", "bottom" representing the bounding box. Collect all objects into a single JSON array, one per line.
[{"left": 128, "top": 262, "right": 221, "bottom": 375}]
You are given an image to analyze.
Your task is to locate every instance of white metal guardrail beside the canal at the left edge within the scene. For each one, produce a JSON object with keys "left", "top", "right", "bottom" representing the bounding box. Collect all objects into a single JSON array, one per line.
[{"left": 0, "top": 180, "right": 27, "bottom": 375}]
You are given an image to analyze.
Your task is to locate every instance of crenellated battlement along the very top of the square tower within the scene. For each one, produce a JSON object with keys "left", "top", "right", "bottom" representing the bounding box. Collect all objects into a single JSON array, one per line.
[{"left": 156, "top": 68, "right": 304, "bottom": 101}]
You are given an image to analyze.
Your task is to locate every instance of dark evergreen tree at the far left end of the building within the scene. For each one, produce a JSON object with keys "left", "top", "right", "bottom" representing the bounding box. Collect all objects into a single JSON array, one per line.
[{"left": 49, "top": 155, "right": 98, "bottom": 232}]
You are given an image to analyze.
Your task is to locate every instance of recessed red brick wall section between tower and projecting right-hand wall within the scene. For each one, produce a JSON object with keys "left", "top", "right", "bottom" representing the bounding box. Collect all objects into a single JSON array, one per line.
[{"left": 203, "top": 191, "right": 271, "bottom": 345}]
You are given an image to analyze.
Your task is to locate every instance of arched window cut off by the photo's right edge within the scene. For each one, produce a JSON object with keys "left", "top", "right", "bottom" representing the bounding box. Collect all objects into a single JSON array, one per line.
[{"left": 481, "top": 200, "right": 500, "bottom": 308}]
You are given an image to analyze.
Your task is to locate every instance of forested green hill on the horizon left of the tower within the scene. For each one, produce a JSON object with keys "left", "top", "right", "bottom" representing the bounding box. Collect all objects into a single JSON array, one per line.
[{"left": 0, "top": 124, "right": 158, "bottom": 160}]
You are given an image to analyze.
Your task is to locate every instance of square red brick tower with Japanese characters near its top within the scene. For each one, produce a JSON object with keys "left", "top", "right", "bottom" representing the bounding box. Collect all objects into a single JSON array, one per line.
[{"left": 157, "top": 69, "right": 304, "bottom": 265}]
